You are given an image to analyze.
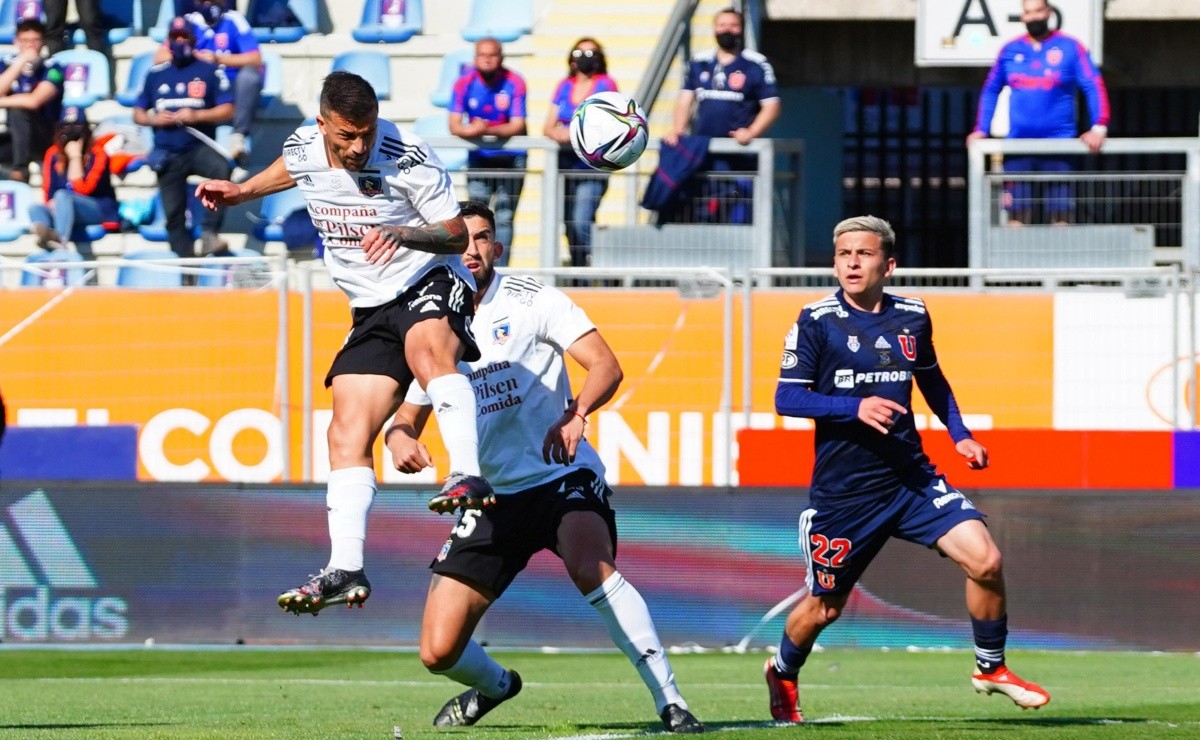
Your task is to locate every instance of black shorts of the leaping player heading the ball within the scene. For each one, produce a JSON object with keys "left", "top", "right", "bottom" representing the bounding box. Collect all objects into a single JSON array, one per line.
[{"left": 325, "top": 267, "right": 479, "bottom": 392}]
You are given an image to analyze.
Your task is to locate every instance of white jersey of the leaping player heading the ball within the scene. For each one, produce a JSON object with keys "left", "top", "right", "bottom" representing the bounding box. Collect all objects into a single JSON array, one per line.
[{"left": 283, "top": 119, "right": 475, "bottom": 307}]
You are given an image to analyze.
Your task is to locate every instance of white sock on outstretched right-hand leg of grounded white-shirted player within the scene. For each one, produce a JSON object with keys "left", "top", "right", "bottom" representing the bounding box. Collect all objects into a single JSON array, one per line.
[{"left": 586, "top": 573, "right": 688, "bottom": 714}]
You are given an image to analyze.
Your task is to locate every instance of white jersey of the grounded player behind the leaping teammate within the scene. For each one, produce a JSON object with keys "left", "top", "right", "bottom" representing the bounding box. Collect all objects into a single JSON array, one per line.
[{"left": 406, "top": 273, "right": 605, "bottom": 494}]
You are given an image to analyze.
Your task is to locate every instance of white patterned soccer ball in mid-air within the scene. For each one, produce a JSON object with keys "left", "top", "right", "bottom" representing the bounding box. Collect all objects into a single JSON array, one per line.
[{"left": 571, "top": 92, "right": 648, "bottom": 172}]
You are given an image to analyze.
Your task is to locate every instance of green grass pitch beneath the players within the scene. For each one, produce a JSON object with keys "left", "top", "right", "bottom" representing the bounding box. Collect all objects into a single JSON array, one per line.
[{"left": 0, "top": 649, "right": 1200, "bottom": 740}]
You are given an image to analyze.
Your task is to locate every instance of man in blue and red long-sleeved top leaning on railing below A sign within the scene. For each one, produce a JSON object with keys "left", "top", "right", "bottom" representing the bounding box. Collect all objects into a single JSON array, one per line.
[{"left": 967, "top": 0, "right": 1109, "bottom": 225}]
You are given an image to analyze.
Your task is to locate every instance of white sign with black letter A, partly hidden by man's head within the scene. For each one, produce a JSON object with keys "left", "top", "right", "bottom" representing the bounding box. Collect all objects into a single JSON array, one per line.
[{"left": 916, "top": 0, "right": 1104, "bottom": 67}]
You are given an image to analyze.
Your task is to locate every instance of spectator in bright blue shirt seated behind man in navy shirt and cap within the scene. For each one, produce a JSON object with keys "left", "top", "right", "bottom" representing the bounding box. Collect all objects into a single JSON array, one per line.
[{"left": 154, "top": 0, "right": 263, "bottom": 166}]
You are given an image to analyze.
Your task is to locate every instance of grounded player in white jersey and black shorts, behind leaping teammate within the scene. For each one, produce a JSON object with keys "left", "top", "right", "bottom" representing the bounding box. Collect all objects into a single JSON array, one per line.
[{"left": 371, "top": 201, "right": 704, "bottom": 733}]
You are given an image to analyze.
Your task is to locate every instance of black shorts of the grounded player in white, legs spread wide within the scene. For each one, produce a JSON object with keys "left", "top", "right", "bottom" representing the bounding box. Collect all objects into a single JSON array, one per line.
[{"left": 430, "top": 470, "right": 617, "bottom": 597}]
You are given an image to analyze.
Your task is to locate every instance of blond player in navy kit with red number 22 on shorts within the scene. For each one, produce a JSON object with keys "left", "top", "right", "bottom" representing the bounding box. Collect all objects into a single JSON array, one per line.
[{"left": 763, "top": 216, "right": 1050, "bottom": 722}]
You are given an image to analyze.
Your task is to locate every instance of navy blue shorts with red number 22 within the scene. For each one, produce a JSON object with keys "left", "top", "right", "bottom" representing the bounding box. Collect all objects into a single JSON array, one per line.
[{"left": 800, "top": 475, "right": 984, "bottom": 595}]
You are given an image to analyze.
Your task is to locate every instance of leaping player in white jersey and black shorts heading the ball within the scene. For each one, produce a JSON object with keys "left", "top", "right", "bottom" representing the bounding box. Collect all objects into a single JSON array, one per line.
[{"left": 196, "top": 72, "right": 494, "bottom": 615}]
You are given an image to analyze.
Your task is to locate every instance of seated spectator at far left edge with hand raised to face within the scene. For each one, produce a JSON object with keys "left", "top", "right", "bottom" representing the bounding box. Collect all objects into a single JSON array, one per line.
[{"left": 0, "top": 18, "right": 64, "bottom": 182}]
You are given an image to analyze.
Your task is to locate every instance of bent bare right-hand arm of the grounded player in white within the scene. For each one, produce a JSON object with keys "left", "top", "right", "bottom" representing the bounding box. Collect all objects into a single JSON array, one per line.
[{"left": 541, "top": 329, "right": 625, "bottom": 465}]
